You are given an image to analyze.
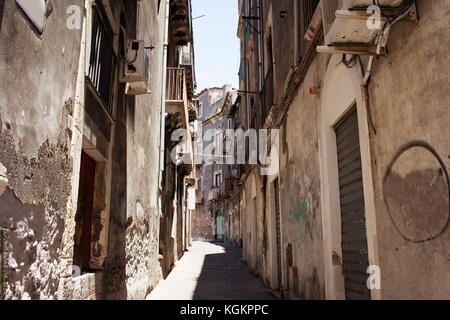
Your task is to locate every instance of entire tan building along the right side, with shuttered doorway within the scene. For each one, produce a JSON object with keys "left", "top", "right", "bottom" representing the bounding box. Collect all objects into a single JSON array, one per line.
[{"left": 234, "top": 0, "right": 450, "bottom": 299}]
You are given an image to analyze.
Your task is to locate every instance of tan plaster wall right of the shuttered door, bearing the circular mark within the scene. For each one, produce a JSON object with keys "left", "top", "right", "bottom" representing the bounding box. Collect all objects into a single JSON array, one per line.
[{"left": 369, "top": 0, "right": 450, "bottom": 299}]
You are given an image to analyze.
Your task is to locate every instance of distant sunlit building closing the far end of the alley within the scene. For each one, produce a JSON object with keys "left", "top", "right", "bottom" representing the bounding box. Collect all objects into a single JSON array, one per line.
[{"left": 192, "top": 85, "right": 237, "bottom": 240}]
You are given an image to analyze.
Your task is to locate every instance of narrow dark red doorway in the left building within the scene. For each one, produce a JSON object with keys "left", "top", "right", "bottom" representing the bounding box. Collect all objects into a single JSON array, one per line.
[{"left": 73, "top": 151, "right": 96, "bottom": 272}]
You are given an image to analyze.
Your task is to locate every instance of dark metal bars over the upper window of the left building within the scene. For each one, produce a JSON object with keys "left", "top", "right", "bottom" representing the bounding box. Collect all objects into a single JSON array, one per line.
[{"left": 88, "top": 10, "right": 115, "bottom": 113}]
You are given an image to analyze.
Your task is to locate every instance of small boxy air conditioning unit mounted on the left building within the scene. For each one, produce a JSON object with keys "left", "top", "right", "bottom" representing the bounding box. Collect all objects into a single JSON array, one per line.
[{"left": 120, "top": 40, "right": 149, "bottom": 83}]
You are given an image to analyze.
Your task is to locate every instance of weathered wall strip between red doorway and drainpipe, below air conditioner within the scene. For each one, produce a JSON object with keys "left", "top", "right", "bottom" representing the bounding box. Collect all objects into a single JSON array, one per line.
[{"left": 103, "top": 1, "right": 165, "bottom": 300}]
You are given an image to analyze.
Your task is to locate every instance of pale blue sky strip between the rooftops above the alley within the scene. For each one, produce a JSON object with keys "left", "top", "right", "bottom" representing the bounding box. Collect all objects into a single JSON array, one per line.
[{"left": 192, "top": 0, "right": 240, "bottom": 93}]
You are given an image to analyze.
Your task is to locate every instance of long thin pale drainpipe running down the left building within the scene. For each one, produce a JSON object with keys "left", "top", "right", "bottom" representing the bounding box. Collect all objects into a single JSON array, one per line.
[{"left": 159, "top": 0, "right": 170, "bottom": 180}]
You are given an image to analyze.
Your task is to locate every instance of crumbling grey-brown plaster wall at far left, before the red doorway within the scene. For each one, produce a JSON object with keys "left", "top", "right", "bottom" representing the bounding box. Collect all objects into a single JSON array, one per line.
[{"left": 0, "top": 0, "right": 82, "bottom": 299}]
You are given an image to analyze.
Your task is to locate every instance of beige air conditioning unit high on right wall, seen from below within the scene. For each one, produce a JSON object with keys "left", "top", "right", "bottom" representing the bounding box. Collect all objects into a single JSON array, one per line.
[{"left": 322, "top": 0, "right": 404, "bottom": 46}]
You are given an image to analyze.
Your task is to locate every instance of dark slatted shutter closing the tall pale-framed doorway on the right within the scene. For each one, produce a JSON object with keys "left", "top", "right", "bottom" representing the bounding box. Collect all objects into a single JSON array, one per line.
[{"left": 335, "top": 106, "right": 370, "bottom": 300}]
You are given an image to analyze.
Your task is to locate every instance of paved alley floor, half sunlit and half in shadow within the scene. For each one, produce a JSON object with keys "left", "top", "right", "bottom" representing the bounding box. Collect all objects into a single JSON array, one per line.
[{"left": 147, "top": 242, "right": 272, "bottom": 300}]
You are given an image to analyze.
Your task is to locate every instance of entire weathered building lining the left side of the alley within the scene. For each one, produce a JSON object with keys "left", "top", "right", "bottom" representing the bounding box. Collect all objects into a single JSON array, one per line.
[{"left": 0, "top": 0, "right": 195, "bottom": 299}]
